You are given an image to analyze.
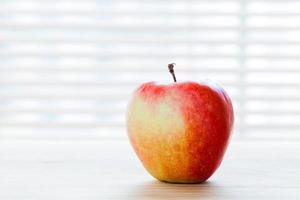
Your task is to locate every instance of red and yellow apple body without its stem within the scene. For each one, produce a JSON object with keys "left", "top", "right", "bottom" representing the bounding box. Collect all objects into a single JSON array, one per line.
[{"left": 127, "top": 82, "right": 234, "bottom": 183}]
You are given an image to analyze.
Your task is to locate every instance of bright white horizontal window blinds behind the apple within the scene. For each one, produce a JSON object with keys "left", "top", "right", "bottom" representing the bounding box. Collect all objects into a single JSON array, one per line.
[{"left": 0, "top": 0, "right": 300, "bottom": 139}]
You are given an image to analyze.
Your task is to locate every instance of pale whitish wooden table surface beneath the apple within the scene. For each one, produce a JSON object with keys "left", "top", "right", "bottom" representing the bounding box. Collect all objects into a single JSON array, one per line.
[{"left": 0, "top": 140, "right": 300, "bottom": 200}]
